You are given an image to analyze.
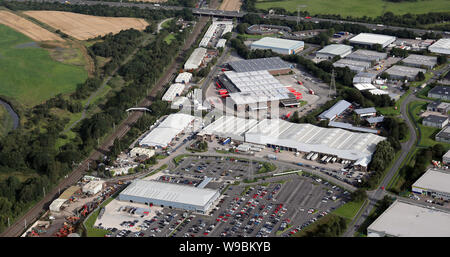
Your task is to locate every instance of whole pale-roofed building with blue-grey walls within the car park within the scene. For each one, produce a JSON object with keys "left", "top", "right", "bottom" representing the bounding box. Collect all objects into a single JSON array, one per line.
[{"left": 118, "top": 180, "right": 220, "bottom": 213}]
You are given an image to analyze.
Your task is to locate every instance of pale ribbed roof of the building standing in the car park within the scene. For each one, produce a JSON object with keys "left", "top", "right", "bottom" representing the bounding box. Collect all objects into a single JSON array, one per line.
[{"left": 119, "top": 180, "right": 218, "bottom": 206}]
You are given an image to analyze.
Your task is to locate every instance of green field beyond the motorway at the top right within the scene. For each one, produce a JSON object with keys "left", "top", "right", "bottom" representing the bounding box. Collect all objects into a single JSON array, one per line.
[{"left": 256, "top": 0, "right": 450, "bottom": 17}]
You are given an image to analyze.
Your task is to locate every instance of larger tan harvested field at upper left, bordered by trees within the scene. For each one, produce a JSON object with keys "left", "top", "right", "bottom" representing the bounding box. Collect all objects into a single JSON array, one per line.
[{"left": 24, "top": 11, "right": 149, "bottom": 40}]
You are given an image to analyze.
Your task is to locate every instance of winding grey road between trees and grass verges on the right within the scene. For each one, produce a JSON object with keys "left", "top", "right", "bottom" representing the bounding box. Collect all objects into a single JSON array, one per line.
[{"left": 343, "top": 65, "right": 450, "bottom": 237}]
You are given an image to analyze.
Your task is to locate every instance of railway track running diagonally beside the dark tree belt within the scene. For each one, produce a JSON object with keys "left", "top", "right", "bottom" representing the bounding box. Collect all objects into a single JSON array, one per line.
[{"left": 0, "top": 16, "right": 209, "bottom": 237}]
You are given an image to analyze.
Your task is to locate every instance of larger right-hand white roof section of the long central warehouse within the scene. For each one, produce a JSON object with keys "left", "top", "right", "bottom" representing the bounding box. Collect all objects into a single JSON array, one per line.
[{"left": 245, "top": 119, "right": 385, "bottom": 160}]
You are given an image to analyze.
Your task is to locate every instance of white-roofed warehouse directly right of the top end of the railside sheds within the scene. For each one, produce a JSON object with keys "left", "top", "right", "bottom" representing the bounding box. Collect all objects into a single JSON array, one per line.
[{"left": 250, "top": 37, "right": 305, "bottom": 54}]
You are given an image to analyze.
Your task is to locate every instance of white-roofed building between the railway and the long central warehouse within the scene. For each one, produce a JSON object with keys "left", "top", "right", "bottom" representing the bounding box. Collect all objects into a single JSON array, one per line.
[{"left": 139, "top": 113, "right": 195, "bottom": 148}]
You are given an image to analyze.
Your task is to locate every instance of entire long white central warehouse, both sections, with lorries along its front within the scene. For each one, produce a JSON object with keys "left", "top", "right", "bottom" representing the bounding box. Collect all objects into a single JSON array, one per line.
[{"left": 199, "top": 117, "right": 385, "bottom": 167}]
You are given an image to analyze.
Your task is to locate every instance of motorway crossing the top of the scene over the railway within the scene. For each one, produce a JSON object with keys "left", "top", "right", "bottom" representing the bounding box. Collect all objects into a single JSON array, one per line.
[{"left": 8, "top": 0, "right": 448, "bottom": 37}]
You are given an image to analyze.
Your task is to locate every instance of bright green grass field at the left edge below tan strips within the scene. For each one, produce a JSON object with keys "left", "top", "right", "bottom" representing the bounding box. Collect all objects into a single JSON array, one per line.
[{"left": 0, "top": 25, "right": 87, "bottom": 107}]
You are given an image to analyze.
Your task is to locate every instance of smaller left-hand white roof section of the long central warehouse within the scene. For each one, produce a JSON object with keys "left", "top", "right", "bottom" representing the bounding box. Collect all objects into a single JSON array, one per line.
[{"left": 198, "top": 116, "right": 258, "bottom": 141}]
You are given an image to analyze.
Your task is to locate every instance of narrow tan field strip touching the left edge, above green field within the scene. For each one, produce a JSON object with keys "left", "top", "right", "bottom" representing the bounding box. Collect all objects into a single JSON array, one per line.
[{"left": 0, "top": 11, "right": 64, "bottom": 41}]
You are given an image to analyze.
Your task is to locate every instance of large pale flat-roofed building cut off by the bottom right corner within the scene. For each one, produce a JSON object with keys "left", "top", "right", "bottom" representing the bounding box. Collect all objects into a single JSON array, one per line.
[{"left": 367, "top": 200, "right": 450, "bottom": 237}]
